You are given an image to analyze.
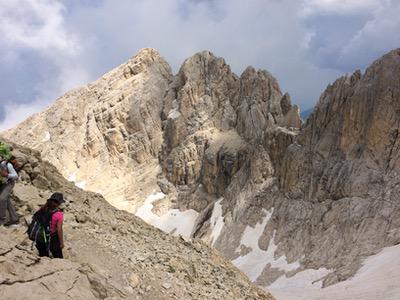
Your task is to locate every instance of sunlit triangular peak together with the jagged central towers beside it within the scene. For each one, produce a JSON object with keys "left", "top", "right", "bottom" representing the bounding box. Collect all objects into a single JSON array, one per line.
[{"left": 3, "top": 49, "right": 301, "bottom": 211}]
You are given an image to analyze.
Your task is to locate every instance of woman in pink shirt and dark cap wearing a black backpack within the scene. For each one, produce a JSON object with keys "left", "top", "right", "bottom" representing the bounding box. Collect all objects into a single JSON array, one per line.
[{"left": 33, "top": 193, "right": 65, "bottom": 258}]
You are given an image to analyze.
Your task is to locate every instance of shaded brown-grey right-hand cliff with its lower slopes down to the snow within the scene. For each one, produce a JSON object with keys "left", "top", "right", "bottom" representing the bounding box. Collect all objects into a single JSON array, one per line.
[{"left": 211, "top": 50, "right": 400, "bottom": 285}]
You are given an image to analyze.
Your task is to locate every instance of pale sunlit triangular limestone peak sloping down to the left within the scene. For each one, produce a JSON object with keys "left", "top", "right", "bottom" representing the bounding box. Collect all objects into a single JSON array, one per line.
[{"left": 4, "top": 49, "right": 172, "bottom": 206}]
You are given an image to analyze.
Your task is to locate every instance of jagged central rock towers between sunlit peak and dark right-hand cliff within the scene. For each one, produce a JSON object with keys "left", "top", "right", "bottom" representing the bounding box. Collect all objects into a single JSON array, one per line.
[{"left": 160, "top": 51, "right": 301, "bottom": 201}]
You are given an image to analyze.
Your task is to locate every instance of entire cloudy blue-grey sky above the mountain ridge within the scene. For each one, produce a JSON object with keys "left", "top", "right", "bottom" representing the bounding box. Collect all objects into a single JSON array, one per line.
[{"left": 0, "top": 0, "right": 400, "bottom": 130}]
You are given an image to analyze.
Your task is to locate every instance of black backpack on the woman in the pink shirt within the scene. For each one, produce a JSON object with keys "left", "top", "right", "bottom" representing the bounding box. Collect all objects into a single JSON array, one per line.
[{"left": 27, "top": 209, "right": 57, "bottom": 245}]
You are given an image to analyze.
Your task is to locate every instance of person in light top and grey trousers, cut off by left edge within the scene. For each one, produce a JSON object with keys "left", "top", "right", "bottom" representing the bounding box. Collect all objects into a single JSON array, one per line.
[{"left": 0, "top": 156, "right": 19, "bottom": 226}]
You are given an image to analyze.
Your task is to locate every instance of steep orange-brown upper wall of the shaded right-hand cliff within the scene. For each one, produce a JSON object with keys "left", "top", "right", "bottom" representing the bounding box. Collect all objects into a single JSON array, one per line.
[{"left": 299, "top": 49, "right": 400, "bottom": 169}]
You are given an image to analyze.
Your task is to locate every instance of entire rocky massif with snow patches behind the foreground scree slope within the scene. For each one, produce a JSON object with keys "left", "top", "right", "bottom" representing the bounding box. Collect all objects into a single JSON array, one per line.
[{"left": 4, "top": 49, "right": 400, "bottom": 299}]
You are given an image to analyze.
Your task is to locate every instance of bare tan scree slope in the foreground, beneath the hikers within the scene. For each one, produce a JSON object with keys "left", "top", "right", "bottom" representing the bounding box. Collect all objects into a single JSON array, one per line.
[{"left": 0, "top": 142, "right": 273, "bottom": 300}]
